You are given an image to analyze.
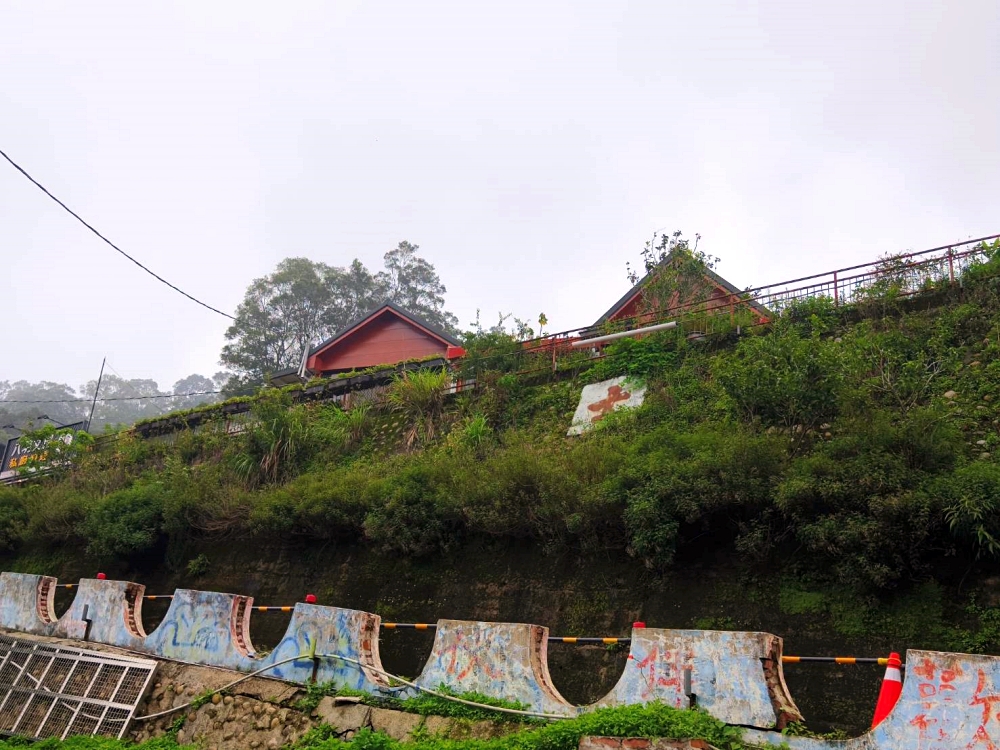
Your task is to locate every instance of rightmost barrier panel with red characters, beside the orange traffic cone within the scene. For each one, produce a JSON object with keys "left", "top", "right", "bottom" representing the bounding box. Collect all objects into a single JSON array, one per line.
[{"left": 744, "top": 650, "right": 1000, "bottom": 750}]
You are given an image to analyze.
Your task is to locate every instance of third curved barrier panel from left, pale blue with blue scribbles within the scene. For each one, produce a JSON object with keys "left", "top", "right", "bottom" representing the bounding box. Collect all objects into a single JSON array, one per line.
[{"left": 140, "top": 589, "right": 260, "bottom": 672}]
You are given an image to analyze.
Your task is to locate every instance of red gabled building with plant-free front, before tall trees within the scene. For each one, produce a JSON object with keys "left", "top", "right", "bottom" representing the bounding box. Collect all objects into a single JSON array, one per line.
[{"left": 270, "top": 302, "right": 465, "bottom": 386}]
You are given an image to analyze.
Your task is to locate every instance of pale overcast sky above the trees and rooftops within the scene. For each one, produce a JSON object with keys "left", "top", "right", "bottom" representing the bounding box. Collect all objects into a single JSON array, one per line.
[{"left": 0, "top": 0, "right": 1000, "bottom": 394}]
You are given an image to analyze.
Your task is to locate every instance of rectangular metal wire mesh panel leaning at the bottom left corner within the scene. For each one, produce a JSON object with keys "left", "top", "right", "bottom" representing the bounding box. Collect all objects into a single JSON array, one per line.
[{"left": 0, "top": 636, "right": 156, "bottom": 739}]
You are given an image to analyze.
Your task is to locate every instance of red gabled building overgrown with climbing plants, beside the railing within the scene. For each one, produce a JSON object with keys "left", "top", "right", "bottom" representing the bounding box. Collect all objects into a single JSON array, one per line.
[{"left": 594, "top": 250, "right": 773, "bottom": 327}]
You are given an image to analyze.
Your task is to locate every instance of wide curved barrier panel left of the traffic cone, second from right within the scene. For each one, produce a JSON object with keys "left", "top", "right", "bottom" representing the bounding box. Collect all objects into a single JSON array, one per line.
[{"left": 593, "top": 628, "right": 802, "bottom": 729}]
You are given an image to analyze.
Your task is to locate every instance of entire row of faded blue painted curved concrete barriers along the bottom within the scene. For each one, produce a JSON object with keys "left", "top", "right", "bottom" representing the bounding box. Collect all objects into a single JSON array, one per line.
[{"left": 9, "top": 573, "right": 1000, "bottom": 750}]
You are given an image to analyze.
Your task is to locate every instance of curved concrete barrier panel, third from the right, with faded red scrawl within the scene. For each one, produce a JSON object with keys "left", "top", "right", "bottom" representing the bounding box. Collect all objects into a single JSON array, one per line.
[{"left": 414, "top": 620, "right": 577, "bottom": 715}]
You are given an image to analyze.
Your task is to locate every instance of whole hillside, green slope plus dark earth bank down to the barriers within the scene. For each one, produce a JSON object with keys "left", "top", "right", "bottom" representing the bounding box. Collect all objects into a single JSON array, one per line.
[{"left": 0, "top": 245, "right": 1000, "bottom": 736}]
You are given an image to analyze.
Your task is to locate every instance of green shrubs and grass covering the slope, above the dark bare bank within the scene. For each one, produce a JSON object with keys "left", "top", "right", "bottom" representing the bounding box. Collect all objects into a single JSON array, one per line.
[{"left": 0, "top": 248, "right": 1000, "bottom": 608}]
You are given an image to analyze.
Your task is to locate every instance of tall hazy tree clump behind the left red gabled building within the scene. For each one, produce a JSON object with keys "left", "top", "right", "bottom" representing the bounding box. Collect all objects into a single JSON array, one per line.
[{"left": 220, "top": 241, "right": 458, "bottom": 388}]
